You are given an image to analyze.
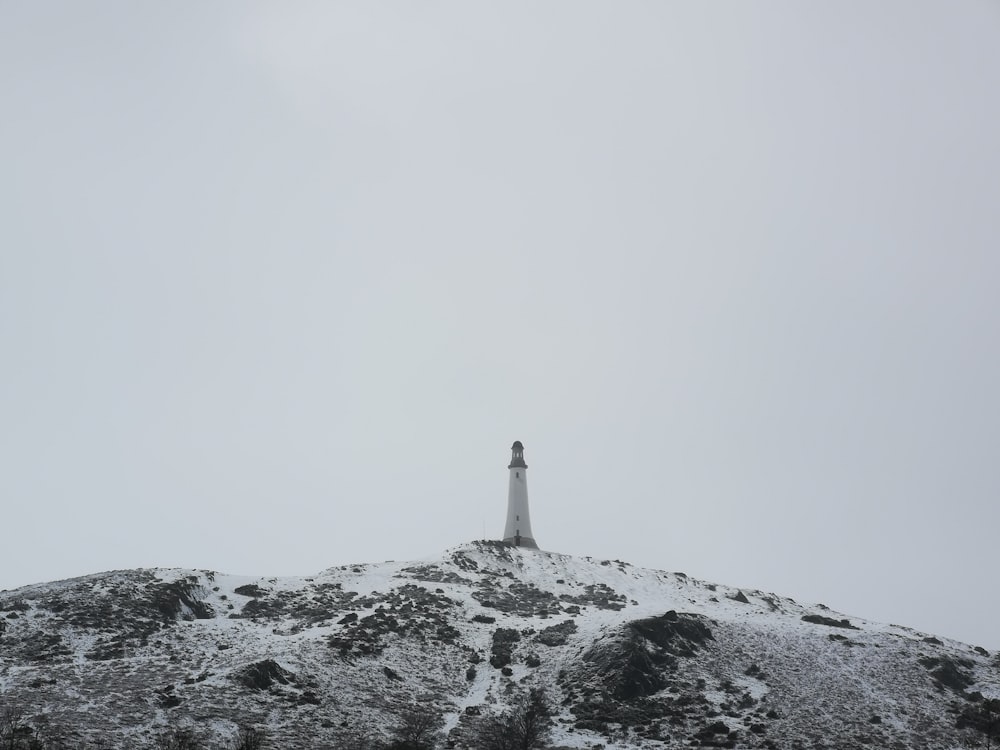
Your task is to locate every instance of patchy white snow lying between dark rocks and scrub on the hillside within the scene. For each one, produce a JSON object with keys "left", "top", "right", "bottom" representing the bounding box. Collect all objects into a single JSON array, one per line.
[{"left": 0, "top": 543, "right": 1000, "bottom": 749}]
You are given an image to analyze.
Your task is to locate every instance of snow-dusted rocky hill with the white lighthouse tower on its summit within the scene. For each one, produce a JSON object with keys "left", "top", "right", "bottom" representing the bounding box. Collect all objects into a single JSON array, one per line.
[{"left": 0, "top": 542, "right": 1000, "bottom": 749}]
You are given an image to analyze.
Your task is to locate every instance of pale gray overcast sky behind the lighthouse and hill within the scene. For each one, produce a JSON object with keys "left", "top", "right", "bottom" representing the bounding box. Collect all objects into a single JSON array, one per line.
[{"left": 0, "top": 0, "right": 1000, "bottom": 648}]
